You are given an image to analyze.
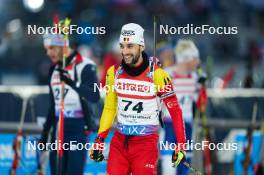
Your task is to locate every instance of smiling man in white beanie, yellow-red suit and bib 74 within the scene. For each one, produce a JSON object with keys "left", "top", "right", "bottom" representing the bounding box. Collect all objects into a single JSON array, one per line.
[{"left": 90, "top": 23, "right": 186, "bottom": 175}]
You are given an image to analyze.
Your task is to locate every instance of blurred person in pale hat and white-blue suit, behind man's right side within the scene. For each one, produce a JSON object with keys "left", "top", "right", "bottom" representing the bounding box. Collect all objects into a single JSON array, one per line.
[{"left": 161, "top": 39, "right": 206, "bottom": 175}]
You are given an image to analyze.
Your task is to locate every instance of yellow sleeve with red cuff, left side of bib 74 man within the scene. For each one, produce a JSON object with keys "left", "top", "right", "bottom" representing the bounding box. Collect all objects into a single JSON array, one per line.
[{"left": 98, "top": 66, "right": 117, "bottom": 139}]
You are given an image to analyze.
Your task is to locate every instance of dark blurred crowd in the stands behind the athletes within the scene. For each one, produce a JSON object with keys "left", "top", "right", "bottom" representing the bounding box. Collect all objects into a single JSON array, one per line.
[{"left": 0, "top": 0, "right": 264, "bottom": 88}]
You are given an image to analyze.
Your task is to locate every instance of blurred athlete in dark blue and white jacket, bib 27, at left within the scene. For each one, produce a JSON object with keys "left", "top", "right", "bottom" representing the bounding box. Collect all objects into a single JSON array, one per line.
[{"left": 40, "top": 31, "right": 100, "bottom": 175}]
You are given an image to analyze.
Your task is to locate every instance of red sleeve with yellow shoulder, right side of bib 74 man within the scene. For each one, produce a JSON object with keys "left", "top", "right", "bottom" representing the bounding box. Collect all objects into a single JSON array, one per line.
[{"left": 154, "top": 68, "right": 186, "bottom": 149}]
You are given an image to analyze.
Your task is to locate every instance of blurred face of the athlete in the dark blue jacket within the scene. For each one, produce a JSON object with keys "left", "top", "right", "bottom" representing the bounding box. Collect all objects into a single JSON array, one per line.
[{"left": 44, "top": 46, "right": 63, "bottom": 64}]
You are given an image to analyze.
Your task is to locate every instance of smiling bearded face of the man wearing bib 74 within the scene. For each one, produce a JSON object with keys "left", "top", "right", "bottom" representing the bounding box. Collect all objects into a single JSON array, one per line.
[{"left": 120, "top": 43, "right": 144, "bottom": 66}]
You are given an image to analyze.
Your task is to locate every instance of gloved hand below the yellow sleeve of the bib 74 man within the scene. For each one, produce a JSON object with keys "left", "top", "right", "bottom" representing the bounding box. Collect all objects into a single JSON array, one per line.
[{"left": 90, "top": 137, "right": 104, "bottom": 162}]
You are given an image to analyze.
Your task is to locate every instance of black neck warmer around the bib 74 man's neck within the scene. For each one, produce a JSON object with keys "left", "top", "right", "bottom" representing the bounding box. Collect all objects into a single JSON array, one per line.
[{"left": 121, "top": 52, "right": 149, "bottom": 76}]
